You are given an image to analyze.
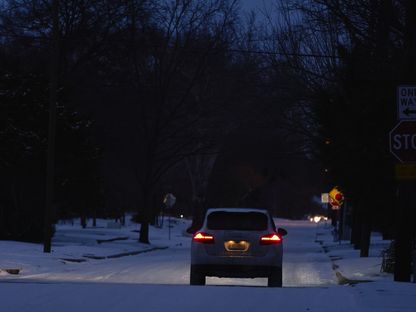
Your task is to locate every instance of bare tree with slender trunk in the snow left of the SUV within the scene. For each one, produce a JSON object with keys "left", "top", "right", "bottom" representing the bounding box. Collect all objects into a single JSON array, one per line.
[{"left": 115, "top": 0, "right": 240, "bottom": 243}]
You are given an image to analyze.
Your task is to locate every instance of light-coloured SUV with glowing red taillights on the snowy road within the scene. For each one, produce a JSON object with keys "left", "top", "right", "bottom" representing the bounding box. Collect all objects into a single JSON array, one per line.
[{"left": 190, "top": 208, "right": 287, "bottom": 287}]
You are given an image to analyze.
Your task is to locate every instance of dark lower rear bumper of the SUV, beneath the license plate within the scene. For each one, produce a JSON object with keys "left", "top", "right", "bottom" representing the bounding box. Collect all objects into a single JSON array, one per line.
[{"left": 192, "top": 264, "right": 281, "bottom": 278}]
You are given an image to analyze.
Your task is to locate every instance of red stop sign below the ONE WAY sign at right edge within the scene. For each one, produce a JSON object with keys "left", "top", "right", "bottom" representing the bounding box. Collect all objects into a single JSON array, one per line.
[{"left": 390, "top": 120, "right": 416, "bottom": 162}]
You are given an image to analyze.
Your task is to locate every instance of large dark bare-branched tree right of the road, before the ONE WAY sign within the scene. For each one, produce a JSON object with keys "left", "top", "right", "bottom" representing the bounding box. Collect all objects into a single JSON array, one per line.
[{"left": 262, "top": 0, "right": 414, "bottom": 256}]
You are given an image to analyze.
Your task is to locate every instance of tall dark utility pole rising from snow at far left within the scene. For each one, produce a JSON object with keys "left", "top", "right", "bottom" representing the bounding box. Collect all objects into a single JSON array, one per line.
[{"left": 43, "top": 0, "right": 59, "bottom": 253}]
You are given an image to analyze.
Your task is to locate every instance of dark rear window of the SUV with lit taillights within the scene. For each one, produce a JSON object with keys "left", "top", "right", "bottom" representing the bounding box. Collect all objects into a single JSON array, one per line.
[{"left": 207, "top": 211, "right": 268, "bottom": 231}]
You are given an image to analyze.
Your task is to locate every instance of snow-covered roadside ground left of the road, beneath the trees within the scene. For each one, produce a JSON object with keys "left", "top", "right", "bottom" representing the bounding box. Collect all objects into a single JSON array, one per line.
[{"left": 0, "top": 218, "right": 190, "bottom": 280}]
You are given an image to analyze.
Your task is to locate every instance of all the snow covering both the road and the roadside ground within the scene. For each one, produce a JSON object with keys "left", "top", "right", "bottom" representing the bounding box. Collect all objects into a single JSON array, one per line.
[{"left": 0, "top": 219, "right": 416, "bottom": 312}]
